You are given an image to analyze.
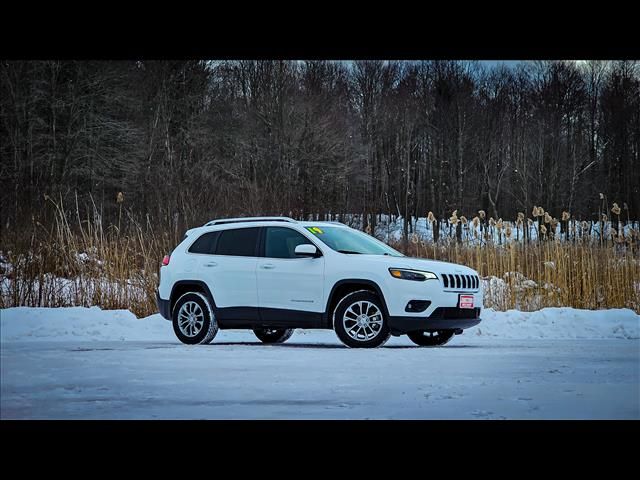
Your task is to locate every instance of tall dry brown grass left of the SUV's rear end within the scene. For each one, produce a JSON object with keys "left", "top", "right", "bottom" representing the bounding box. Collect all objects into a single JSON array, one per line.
[{"left": 0, "top": 198, "right": 179, "bottom": 316}]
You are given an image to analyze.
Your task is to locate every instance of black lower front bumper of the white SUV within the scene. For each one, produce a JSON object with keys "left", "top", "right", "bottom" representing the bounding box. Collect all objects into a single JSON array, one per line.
[{"left": 388, "top": 307, "right": 481, "bottom": 335}]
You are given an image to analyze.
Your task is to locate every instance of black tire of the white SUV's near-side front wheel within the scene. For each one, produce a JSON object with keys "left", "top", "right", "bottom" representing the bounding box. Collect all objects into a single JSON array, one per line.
[{"left": 333, "top": 290, "right": 391, "bottom": 348}]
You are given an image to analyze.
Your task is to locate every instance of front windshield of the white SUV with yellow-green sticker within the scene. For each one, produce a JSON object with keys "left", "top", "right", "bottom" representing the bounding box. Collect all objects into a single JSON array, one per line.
[{"left": 306, "top": 227, "right": 404, "bottom": 257}]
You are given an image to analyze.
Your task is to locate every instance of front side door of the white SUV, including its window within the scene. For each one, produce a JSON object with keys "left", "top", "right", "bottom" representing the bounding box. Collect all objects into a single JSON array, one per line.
[{"left": 257, "top": 227, "right": 325, "bottom": 326}]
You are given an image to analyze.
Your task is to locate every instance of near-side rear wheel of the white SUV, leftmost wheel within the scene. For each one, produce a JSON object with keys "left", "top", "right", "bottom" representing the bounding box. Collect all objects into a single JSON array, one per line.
[{"left": 171, "top": 292, "right": 218, "bottom": 345}]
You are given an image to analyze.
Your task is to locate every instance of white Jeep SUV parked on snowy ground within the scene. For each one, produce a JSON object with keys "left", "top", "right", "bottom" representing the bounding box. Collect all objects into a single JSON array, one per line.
[{"left": 156, "top": 217, "right": 482, "bottom": 347}]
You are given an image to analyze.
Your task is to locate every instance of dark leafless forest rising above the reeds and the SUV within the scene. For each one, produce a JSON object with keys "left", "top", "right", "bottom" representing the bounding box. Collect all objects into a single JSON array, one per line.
[{"left": 0, "top": 61, "right": 640, "bottom": 233}]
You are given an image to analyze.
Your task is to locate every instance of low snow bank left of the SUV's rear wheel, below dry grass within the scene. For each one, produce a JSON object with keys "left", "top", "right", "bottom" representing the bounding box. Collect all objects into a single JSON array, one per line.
[{"left": 0, "top": 307, "right": 176, "bottom": 342}]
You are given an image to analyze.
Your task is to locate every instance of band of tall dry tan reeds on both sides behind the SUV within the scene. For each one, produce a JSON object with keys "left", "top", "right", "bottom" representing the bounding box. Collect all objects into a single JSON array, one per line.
[{"left": 0, "top": 199, "right": 640, "bottom": 316}]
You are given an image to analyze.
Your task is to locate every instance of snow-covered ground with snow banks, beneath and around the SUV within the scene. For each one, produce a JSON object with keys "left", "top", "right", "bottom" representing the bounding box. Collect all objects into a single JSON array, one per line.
[{"left": 0, "top": 307, "right": 640, "bottom": 419}]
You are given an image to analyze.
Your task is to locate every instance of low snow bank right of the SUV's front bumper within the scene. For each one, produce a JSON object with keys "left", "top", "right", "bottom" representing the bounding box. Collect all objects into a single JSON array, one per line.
[{"left": 472, "top": 307, "right": 640, "bottom": 339}]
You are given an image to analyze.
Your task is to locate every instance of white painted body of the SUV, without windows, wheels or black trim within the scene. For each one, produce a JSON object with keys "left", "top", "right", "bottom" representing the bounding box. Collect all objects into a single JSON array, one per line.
[{"left": 160, "top": 221, "right": 483, "bottom": 317}]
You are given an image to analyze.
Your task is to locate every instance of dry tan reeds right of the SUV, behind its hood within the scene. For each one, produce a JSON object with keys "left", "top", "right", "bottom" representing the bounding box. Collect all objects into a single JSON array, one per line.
[{"left": 399, "top": 242, "right": 640, "bottom": 313}]
